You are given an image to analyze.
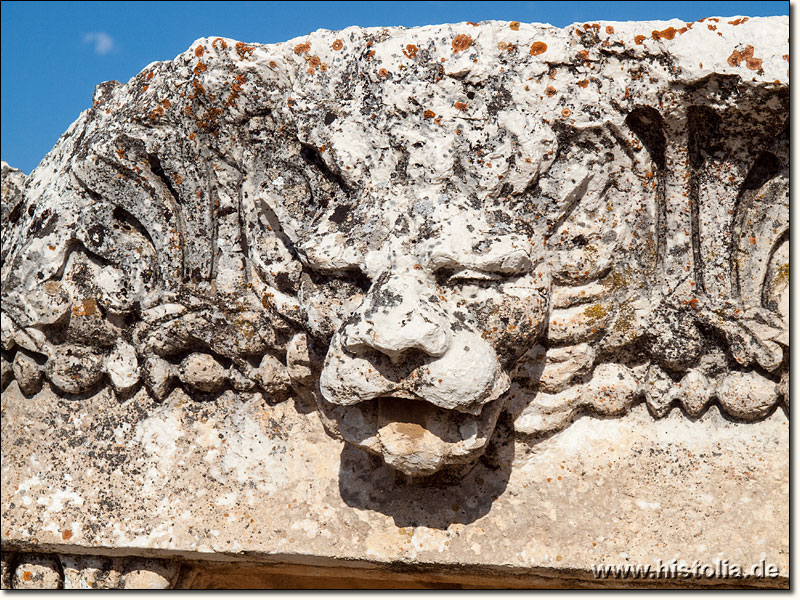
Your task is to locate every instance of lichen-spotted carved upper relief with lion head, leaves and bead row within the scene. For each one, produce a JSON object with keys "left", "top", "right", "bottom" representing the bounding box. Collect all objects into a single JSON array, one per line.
[{"left": 2, "top": 19, "right": 789, "bottom": 475}]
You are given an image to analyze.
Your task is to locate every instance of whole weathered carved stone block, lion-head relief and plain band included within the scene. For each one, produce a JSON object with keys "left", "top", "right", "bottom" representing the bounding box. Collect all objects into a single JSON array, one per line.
[{"left": 2, "top": 17, "right": 789, "bottom": 587}]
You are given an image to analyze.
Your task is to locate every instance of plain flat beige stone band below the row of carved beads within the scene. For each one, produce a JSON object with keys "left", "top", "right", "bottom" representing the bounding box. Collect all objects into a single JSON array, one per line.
[{"left": 2, "top": 383, "right": 789, "bottom": 587}]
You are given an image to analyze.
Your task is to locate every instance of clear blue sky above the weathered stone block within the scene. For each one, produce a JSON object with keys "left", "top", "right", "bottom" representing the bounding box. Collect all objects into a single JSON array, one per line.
[{"left": 0, "top": 1, "right": 789, "bottom": 173}]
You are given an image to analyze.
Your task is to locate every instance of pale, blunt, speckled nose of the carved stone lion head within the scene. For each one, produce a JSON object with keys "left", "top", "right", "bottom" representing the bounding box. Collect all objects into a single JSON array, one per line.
[{"left": 342, "top": 273, "right": 450, "bottom": 361}]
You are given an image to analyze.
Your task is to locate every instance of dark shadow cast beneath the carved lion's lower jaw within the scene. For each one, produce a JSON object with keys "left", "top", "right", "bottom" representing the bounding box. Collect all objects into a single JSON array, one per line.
[{"left": 339, "top": 412, "right": 514, "bottom": 529}]
